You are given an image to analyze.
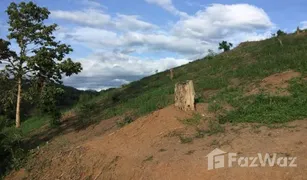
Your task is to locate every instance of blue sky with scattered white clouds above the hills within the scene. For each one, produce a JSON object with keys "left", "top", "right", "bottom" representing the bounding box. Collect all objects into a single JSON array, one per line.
[{"left": 0, "top": 0, "right": 307, "bottom": 90}]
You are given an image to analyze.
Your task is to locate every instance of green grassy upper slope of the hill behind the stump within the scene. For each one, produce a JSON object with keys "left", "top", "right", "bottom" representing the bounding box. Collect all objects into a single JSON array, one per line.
[{"left": 77, "top": 34, "right": 307, "bottom": 123}]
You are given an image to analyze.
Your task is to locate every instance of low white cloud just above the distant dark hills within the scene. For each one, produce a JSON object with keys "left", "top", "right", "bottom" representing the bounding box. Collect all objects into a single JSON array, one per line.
[{"left": 80, "top": 52, "right": 189, "bottom": 79}]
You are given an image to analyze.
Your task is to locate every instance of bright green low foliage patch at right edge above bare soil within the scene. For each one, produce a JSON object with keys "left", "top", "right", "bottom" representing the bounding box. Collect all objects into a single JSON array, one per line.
[{"left": 220, "top": 79, "right": 307, "bottom": 124}]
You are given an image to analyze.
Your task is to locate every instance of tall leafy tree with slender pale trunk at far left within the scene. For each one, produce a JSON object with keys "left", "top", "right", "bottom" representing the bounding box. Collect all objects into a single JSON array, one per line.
[{"left": 5, "top": 2, "right": 82, "bottom": 128}]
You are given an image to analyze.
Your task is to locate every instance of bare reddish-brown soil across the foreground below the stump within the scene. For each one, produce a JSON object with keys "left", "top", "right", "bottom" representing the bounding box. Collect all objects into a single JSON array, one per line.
[{"left": 7, "top": 105, "right": 307, "bottom": 180}]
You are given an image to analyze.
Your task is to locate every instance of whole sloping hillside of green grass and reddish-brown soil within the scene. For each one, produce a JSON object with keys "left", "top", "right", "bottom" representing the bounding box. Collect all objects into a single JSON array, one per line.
[{"left": 7, "top": 33, "right": 307, "bottom": 180}]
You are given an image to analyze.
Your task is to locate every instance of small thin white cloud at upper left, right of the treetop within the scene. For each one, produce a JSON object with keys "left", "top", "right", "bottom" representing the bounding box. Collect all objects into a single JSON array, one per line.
[{"left": 51, "top": 9, "right": 111, "bottom": 27}]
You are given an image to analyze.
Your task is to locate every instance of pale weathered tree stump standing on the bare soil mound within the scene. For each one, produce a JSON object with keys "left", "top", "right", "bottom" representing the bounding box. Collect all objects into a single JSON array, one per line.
[{"left": 175, "top": 80, "right": 195, "bottom": 111}]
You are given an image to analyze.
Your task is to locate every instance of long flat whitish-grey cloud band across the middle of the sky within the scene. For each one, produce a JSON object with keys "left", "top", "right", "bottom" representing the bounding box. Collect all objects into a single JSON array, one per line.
[{"left": 58, "top": 27, "right": 215, "bottom": 54}]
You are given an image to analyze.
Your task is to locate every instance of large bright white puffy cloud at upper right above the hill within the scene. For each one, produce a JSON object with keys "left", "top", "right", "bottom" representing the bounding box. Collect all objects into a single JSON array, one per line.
[{"left": 173, "top": 4, "right": 273, "bottom": 39}]
